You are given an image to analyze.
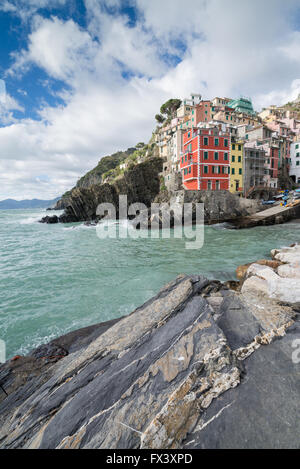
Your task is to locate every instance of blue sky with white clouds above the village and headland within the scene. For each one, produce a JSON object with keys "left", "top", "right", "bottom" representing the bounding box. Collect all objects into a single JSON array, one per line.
[{"left": 0, "top": 0, "right": 300, "bottom": 200}]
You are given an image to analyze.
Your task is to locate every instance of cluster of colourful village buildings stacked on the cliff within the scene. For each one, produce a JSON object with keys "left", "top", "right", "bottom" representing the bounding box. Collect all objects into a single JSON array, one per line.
[{"left": 121, "top": 94, "right": 300, "bottom": 200}]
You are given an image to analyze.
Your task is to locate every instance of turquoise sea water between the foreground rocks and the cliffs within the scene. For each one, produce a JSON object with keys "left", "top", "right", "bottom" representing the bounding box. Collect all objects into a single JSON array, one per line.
[{"left": 0, "top": 210, "right": 300, "bottom": 358}]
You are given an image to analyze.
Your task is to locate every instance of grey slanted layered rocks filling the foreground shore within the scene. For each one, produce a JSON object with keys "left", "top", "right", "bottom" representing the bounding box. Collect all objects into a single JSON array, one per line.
[{"left": 0, "top": 245, "right": 300, "bottom": 449}]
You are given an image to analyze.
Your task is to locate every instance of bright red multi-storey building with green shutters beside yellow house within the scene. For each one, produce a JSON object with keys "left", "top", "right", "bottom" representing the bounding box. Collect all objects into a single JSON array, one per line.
[{"left": 180, "top": 127, "right": 230, "bottom": 190}]
